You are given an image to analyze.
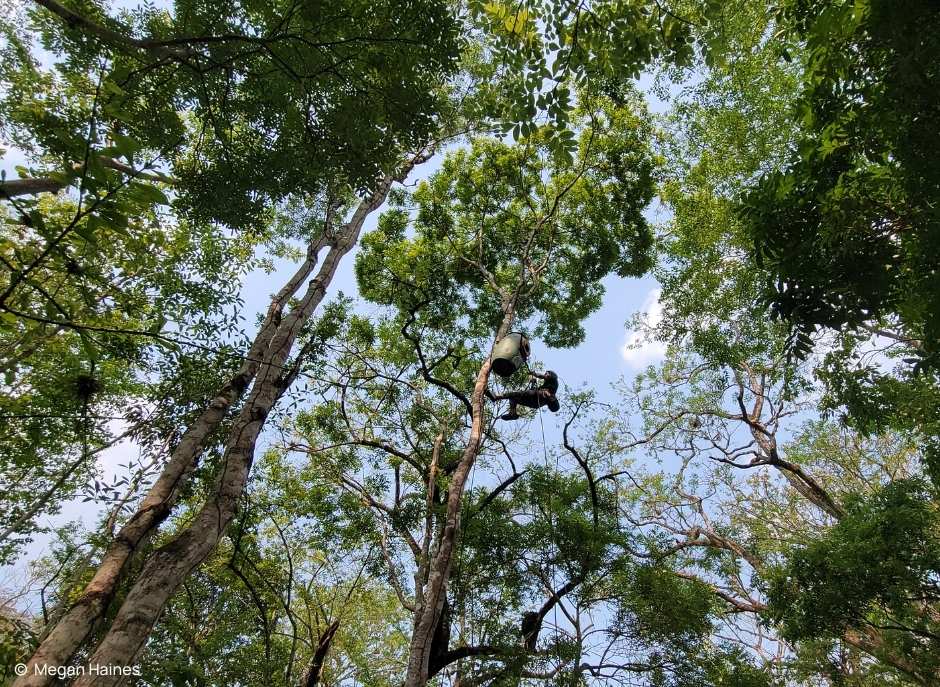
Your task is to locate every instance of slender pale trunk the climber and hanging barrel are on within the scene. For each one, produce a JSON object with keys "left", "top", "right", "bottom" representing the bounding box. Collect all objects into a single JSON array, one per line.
[{"left": 405, "top": 310, "right": 515, "bottom": 687}]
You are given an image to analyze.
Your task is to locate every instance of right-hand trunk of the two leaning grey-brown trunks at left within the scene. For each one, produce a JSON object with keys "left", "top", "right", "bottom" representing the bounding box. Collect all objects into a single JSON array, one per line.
[{"left": 74, "top": 160, "right": 429, "bottom": 687}]
